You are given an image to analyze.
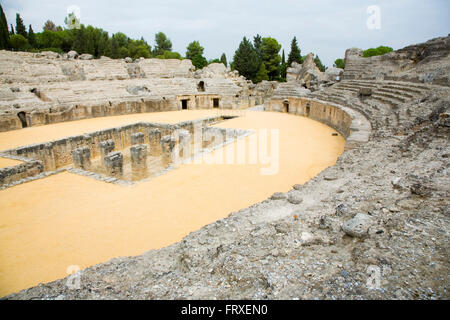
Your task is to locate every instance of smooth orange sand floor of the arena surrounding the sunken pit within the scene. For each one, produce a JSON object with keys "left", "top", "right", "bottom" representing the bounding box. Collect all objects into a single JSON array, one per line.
[{"left": 0, "top": 111, "right": 345, "bottom": 296}]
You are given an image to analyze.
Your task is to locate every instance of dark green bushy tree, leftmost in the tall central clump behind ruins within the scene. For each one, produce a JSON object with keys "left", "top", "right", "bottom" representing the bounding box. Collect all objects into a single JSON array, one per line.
[{"left": 233, "top": 37, "right": 260, "bottom": 81}]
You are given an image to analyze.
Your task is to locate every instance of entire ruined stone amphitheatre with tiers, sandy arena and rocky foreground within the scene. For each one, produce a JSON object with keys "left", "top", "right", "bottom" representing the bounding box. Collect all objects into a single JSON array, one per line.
[{"left": 0, "top": 36, "right": 450, "bottom": 299}]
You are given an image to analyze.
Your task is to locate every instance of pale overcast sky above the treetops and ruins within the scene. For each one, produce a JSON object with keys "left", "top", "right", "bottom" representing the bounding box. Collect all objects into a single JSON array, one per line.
[{"left": 1, "top": 0, "right": 450, "bottom": 66}]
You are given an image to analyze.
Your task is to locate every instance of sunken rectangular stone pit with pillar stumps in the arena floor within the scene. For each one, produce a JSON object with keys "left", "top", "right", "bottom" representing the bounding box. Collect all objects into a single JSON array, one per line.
[{"left": 0, "top": 115, "right": 251, "bottom": 189}]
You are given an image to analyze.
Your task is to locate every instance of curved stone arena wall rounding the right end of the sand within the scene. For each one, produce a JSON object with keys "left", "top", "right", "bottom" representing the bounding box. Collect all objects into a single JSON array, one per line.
[{"left": 265, "top": 97, "right": 371, "bottom": 149}]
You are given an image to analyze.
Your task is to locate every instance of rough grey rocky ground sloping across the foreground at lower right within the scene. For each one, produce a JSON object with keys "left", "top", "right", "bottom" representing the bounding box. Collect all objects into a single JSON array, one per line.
[{"left": 8, "top": 85, "right": 450, "bottom": 299}]
